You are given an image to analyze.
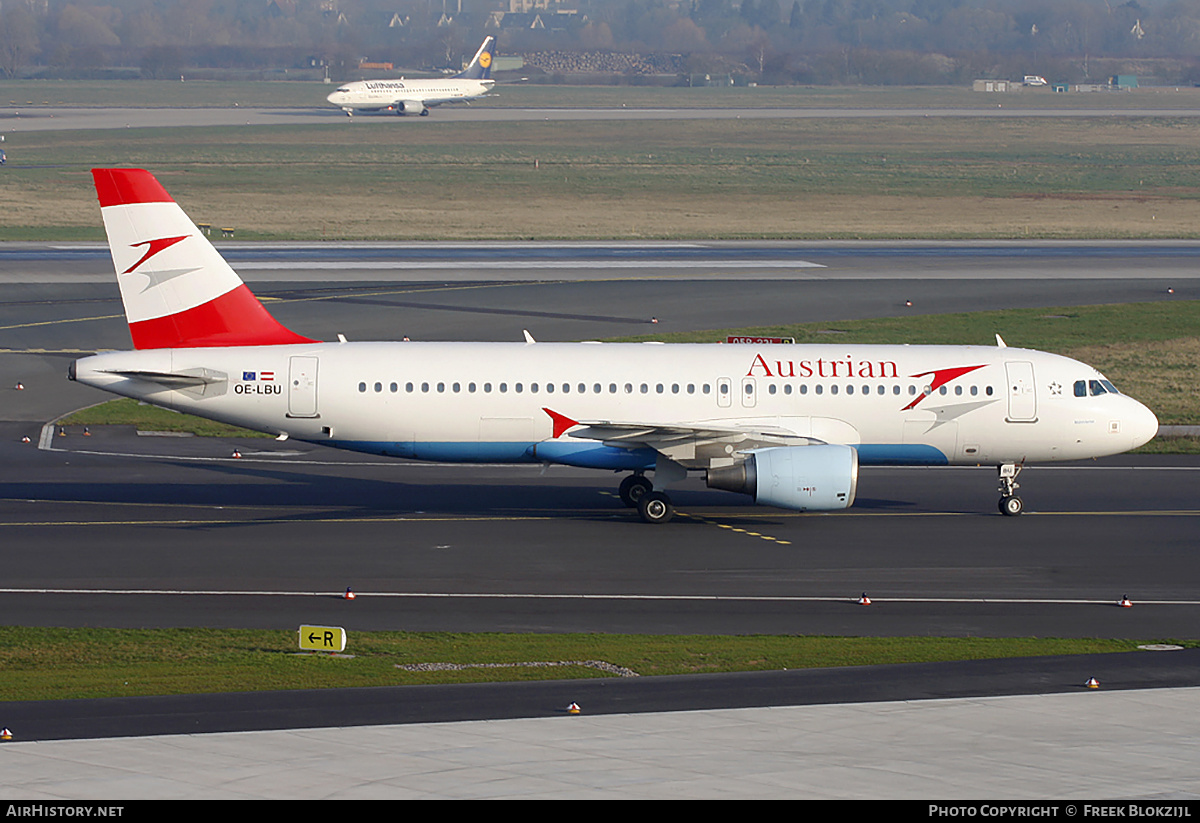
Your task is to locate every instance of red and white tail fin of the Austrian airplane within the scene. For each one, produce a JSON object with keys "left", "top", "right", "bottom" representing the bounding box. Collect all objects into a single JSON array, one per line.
[{"left": 91, "top": 169, "right": 313, "bottom": 349}]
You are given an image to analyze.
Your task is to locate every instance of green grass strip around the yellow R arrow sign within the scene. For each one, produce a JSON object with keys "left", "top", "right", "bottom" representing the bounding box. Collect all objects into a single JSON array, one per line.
[{"left": 0, "top": 626, "right": 1176, "bottom": 701}]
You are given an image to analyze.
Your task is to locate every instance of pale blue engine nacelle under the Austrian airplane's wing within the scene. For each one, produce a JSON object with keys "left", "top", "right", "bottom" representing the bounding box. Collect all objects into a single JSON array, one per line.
[{"left": 707, "top": 445, "right": 858, "bottom": 511}]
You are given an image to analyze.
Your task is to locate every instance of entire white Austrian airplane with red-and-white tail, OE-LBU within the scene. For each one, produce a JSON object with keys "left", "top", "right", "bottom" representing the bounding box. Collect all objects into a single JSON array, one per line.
[{"left": 70, "top": 169, "right": 1158, "bottom": 523}]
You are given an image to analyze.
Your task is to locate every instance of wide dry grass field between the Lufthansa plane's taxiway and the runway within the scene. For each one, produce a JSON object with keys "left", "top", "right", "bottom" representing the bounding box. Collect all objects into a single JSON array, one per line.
[{"left": 0, "top": 110, "right": 1200, "bottom": 241}]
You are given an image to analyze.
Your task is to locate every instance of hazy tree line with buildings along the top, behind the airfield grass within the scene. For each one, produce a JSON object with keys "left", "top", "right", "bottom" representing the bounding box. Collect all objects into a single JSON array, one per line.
[{"left": 0, "top": 0, "right": 1200, "bottom": 84}]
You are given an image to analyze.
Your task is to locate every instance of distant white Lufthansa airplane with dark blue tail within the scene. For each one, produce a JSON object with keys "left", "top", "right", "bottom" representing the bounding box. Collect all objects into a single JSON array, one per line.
[{"left": 325, "top": 37, "right": 496, "bottom": 118}]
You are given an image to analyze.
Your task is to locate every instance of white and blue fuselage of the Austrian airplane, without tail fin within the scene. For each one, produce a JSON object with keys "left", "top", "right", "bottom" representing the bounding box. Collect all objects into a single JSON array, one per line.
[{"left": 74, "top": 342, "right": 1158, "bottom": 470}]
